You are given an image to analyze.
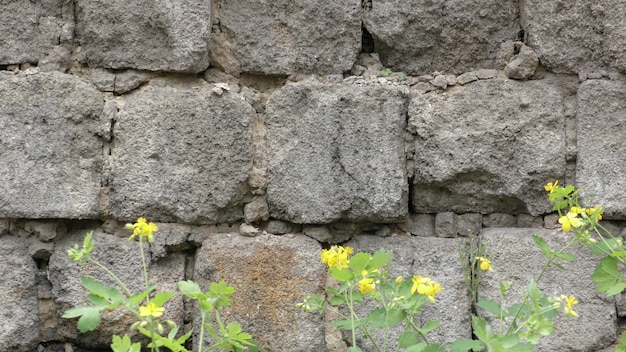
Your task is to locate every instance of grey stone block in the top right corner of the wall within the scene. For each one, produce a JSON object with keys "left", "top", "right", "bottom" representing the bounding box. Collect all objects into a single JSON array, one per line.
[{"left": 521, "top": 0, "right": 626, "bottom": 73}]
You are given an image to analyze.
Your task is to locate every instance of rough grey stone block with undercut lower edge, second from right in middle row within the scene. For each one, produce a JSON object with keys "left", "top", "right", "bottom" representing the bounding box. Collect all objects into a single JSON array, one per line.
[{"left": 408, "top": 79, "right": 565, "bottom": 215}]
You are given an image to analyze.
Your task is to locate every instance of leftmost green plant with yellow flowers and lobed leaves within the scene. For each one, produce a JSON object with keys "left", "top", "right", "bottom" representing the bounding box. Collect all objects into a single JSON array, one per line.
[{"left": 63, "top": 218, "right": 257, "bottom": 352}]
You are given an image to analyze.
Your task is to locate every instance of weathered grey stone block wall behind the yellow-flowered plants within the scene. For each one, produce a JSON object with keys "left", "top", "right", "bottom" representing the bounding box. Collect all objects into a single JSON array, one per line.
[{"left": 0, "top": 0, "right": 626, "bottom": 351}]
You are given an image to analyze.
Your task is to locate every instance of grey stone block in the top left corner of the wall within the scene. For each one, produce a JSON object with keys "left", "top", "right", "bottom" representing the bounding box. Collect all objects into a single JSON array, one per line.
[{"left": 0, "top": 0, "right": 64, "bottom": 65}]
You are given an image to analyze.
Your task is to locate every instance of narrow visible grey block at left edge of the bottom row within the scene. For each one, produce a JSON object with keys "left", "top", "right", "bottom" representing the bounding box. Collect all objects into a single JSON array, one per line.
[{"left": 0, "top": 235, "right": 39, "bottom": 352}]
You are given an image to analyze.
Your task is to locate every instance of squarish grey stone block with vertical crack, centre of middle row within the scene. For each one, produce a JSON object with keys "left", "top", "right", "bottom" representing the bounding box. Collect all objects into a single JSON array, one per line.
[{"left": 266, "top": 83, "right": 408, "bottom": 223}]
